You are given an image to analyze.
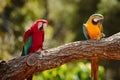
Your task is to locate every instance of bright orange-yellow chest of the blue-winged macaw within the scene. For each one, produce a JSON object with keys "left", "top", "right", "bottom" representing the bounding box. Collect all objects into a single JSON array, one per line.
[{"left": 87, "top": 26, "right": 101, "bottom": 39}]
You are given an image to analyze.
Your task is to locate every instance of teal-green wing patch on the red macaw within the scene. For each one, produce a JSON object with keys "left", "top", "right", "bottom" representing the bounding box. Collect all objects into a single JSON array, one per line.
[{"left": 24, "top": 36, "right": 32, "bottom": 55}]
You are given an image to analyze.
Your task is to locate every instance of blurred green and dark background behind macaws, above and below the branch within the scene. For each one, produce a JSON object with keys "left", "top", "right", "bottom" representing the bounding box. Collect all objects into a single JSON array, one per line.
[{"left": 0, "top": 0, "right": 120, "bottom": 80}]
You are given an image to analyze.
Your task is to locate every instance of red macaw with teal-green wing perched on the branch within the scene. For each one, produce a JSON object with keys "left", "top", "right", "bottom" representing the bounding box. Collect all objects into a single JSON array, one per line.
[{"left": 22, "top": 19, "right": 48, "bottom": 56}]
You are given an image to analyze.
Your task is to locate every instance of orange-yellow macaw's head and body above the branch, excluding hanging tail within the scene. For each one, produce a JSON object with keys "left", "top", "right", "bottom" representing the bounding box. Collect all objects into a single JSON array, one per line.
[{"left": 83, "top": 14, "right": 105, "bottom": 40}]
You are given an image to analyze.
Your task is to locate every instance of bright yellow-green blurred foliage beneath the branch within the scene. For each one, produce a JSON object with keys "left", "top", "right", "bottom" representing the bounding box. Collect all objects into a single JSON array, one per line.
[{"left": 33, "top": 62, "right": 104, "bottom": 80}]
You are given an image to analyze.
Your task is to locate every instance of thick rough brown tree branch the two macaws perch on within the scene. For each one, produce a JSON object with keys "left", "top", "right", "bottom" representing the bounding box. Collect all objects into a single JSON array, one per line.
[{"left": 0, "top": 33, "right": 120, "bottom": 80}]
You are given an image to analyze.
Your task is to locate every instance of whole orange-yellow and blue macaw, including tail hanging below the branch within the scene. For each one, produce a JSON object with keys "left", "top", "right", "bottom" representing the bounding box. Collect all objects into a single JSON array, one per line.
[{"left": 83, "top": 14, "right": 105, "bottom": 80}]
